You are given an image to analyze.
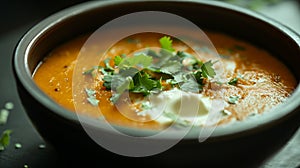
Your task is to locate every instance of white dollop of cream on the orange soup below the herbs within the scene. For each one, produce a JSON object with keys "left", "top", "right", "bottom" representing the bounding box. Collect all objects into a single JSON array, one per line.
[{"left": 141, "top": 88, "right": 212, "bottom": 125}]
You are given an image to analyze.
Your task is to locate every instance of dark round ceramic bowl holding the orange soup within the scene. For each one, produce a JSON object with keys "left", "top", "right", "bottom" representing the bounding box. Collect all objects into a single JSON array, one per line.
[{"left": 13, "top": 0, "right": 300, "bottom": 167}]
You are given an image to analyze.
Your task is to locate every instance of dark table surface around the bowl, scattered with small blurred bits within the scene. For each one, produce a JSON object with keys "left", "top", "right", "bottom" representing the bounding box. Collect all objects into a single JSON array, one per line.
[{"left": 0, "top": 0, "right": 300, "bottom": 168}]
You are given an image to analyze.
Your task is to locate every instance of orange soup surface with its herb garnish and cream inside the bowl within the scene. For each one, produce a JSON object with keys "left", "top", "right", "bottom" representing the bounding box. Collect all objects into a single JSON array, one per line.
[{"left": 33, "top": 32, "right": 296, "bottom": 129}]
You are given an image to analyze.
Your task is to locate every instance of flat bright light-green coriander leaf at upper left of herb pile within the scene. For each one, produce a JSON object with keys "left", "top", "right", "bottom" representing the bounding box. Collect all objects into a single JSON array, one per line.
[{"left": 118, "top": 54, "right": 153, "bottom": 69}]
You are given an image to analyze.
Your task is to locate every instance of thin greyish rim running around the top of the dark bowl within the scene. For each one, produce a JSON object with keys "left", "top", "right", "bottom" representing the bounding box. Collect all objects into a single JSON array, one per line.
[{"left": 13, "top": 0, "right": 300, "bottom": 139}]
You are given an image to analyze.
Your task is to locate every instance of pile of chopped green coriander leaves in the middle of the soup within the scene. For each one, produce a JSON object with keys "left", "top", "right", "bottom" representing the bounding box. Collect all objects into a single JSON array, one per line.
[{"left": 86, "top": 36, "right": 216, "bottom": 104}]
